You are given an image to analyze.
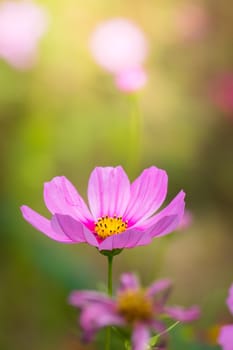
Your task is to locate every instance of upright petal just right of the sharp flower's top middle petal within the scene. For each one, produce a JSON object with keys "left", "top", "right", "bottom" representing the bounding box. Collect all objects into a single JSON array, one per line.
[{"left": 124, "top": 167, "right": 168, "bottom": 226}]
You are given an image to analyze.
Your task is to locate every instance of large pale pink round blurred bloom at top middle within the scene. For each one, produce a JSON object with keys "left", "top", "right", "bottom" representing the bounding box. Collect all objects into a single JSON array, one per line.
[{"left": 90, "top": 18, "right": 148, "bottom": 74}]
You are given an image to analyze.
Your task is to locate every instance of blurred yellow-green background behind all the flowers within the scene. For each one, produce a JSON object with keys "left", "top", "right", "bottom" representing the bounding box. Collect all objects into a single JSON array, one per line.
[{"left": 0, "top": 0, "right": 233, "bottom": 350}]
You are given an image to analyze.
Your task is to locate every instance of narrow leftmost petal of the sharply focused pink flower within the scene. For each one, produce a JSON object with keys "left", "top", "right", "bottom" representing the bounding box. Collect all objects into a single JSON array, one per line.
[{"left": 21, "top": 205, "right": 75, "bottom": 243}]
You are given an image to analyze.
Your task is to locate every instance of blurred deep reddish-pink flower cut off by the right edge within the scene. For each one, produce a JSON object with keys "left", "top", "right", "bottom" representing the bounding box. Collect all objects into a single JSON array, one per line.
[{"left": 210, "top": 72, "right": 233, "bottom": 114}]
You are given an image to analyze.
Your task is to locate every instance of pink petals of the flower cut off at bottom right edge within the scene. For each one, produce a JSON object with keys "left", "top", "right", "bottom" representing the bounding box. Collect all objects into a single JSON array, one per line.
[{"left": 218, "top": 284, "right": 233, "bottom": 350}]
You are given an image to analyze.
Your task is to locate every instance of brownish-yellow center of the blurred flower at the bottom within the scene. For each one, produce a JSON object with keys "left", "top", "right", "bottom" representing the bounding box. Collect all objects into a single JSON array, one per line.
[{"left": 117, "top": 289, "right": 153, "bottom": 323}]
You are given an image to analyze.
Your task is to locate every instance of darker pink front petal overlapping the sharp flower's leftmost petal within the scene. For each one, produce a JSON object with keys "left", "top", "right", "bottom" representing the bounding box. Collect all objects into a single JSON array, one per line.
[{"left": 51, "top": 214, "right": 99, "bottom": 247}]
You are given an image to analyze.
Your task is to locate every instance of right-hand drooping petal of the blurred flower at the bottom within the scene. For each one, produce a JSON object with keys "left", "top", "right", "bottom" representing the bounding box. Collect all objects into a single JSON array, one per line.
[{"left": 164, "top": 306, "right": 200, "bottom": 322}]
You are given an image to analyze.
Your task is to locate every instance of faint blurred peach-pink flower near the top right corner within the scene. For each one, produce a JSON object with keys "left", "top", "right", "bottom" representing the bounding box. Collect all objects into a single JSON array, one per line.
[{"left": 175, "top": 2, "right": 209, "bottom": 41}]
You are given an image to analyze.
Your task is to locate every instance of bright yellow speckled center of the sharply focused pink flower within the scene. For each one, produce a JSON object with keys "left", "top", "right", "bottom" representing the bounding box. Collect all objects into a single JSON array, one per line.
[{"left": 94, "top": 215, "right": 128, "bottom": 238}]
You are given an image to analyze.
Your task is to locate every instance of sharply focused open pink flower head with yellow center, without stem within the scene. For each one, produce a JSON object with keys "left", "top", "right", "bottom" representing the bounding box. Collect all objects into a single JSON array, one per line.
[{"left": 21, "top": 166, "right": 185, "bottom": 250}]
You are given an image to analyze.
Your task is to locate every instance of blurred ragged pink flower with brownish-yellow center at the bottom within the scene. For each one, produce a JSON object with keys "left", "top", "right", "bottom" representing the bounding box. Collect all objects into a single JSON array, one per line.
[{"left": 69, "top": 273, "right": 200, "bottom": 350}]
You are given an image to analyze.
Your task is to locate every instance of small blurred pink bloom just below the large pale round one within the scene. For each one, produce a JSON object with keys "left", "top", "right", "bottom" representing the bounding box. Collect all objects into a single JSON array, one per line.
[{"left": 115, "top": 68, "right": 147, "bottom": 92}]
